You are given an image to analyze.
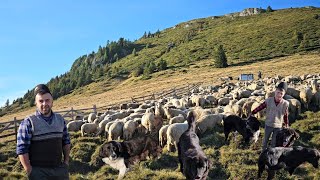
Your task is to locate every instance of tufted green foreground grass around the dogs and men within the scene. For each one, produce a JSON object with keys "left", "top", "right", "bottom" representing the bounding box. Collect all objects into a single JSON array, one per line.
[{"left": 0, "top": 112, "right": 320, "bottom": 180}]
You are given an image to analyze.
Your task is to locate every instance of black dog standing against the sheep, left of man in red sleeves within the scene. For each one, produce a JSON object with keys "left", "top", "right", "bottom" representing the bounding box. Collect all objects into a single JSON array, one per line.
[{"left": 223, "top": 115, "right": 261, "bottom": 143}]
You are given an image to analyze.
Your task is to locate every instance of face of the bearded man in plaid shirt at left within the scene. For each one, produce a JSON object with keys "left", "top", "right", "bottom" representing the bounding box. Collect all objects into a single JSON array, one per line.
[{"left": 35, "top": 93, "right": 53, "bottom": 116}]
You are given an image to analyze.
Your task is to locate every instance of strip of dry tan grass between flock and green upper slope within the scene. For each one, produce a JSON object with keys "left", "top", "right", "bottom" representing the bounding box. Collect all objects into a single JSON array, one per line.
[{"left": 0, "top": 51, "right": 320, "bottom": 122}]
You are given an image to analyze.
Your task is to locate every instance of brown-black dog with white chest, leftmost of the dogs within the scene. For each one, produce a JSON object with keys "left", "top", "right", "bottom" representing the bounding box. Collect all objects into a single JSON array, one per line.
[{"left": 99, "top": 134, "right": 162, "bottom": 179}]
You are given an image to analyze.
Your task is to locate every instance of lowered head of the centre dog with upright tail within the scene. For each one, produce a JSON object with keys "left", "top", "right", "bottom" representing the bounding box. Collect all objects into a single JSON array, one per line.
[{"left": 184, "top": 156, "right": 212, "bottom": 180}]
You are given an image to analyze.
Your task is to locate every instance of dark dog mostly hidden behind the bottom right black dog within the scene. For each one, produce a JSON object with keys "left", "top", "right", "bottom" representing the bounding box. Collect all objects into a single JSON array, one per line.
[{"left": 276, "top": 128, "right": 300, "bottom": 147}]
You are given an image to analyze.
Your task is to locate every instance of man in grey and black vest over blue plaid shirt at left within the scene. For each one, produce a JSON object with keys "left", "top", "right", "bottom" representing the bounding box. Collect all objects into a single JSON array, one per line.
[{"left": 17, "top": 84, "right": 70, "bottom": 180}]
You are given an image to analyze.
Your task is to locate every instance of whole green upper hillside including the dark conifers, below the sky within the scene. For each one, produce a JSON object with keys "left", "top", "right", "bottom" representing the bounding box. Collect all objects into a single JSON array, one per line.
[{"left": 0, "top": 8, "right": 320, "bottom": 116}]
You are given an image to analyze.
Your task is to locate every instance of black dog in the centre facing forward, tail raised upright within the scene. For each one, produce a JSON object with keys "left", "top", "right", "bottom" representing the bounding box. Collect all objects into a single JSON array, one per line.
[{"left": 178, "top": 112, "right": 211, "bottom": 180}]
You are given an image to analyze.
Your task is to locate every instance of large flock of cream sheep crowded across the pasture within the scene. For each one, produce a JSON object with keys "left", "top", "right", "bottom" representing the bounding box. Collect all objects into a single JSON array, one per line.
[{"left": 67, "top": 74, "right": 320, "bottom": 152}]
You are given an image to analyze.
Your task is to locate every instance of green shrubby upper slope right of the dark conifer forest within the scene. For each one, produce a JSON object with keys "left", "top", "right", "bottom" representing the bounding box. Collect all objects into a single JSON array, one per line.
[{"left": 114, "top": 8, "right": 320, "bottom": 72}]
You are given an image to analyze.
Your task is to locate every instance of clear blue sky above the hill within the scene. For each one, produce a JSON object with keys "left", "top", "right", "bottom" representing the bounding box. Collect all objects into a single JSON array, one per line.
[{"left": 0, "top": 0, "right": 320, "bottom": 107}]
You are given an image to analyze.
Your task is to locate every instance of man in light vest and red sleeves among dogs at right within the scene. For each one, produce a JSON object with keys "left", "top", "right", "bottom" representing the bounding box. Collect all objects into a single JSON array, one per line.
[{"left": 251, "top": 82, "right": 289, "bottom": 150}]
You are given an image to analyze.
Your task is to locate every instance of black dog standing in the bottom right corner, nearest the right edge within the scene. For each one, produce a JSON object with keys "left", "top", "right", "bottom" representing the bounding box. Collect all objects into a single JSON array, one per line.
[{"left": 258, "top": 146, "right": 320, "bottom": 179}]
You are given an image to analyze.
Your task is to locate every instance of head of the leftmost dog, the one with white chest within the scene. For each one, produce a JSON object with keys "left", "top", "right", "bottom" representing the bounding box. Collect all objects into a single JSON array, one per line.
[{"left": 99, "top": 141, "right": 122, "bottom": 160}]
